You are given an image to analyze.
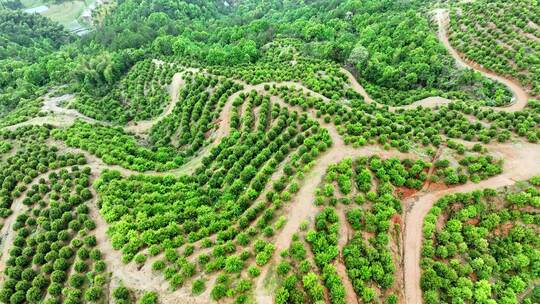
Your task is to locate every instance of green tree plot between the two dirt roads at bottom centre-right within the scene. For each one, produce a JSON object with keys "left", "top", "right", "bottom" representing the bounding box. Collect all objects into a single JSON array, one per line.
[{"left": 275, "top": 150, "right": 506, "bottom": 303}]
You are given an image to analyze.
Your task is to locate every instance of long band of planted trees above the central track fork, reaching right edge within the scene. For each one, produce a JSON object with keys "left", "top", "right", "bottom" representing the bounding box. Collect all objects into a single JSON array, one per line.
[{"left": 277, "top": 85, "right": 540, "bottom": 152}]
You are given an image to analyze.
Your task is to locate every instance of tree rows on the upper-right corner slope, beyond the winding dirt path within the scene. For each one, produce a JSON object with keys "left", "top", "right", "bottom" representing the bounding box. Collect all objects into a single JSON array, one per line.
[{"left": 450, "top": 0, "right": 540, "bottom": 96}]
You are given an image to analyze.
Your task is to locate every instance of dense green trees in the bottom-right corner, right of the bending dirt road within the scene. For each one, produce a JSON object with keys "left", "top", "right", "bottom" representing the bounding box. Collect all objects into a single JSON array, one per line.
[{"left": 421, "top": 177, "right": 540, "bottom": 303}]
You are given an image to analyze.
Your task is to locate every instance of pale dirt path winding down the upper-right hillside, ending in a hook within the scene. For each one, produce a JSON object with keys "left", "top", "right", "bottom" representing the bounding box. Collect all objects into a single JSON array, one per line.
[{"left": 435, "top": 9, "right": 531, "bottom": 112}]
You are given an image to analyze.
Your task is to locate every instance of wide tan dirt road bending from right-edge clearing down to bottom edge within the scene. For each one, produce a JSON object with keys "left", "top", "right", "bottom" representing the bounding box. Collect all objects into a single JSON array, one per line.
[{"left": 404, "top": 143, "right": 540, "bottom": 304}]
